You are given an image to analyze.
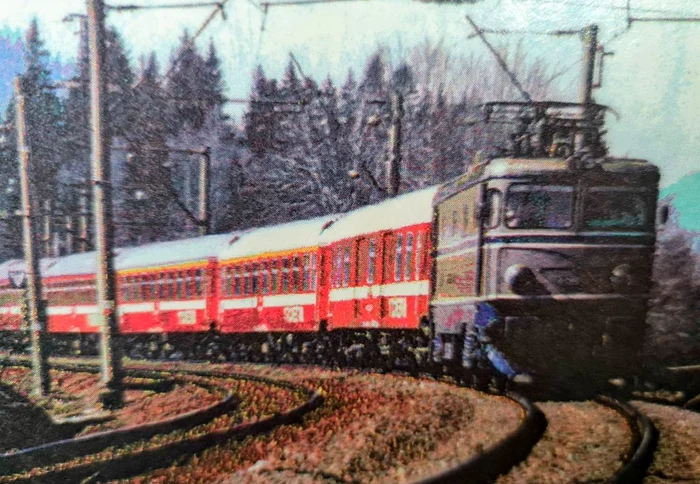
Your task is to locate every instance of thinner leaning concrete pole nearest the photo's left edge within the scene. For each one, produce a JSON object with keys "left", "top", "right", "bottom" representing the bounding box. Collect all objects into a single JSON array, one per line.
[{"left": 15, "top": 77, "right": 51, "bottom": 396}]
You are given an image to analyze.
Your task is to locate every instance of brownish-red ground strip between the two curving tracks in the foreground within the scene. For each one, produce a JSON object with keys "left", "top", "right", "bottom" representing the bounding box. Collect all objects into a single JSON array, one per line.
[{"left": 131, "top": 365, "right": 522, "bottom": 483}]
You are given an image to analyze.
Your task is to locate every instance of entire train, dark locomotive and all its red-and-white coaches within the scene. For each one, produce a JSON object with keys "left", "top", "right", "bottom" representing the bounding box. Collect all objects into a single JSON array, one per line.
[{"left": 0, "top": 103, "right": 659, "bottom": 390}]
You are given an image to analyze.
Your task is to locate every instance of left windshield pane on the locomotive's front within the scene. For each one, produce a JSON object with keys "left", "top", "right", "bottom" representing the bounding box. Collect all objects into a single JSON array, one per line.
[{"left": 505, "top": 183, "right": 574, "bottom": 229}]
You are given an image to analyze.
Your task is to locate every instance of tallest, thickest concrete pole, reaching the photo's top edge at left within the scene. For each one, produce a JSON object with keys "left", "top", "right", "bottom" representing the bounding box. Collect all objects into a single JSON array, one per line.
[{"left": 87, "top": 0, "right": 123, "bottom": 407}]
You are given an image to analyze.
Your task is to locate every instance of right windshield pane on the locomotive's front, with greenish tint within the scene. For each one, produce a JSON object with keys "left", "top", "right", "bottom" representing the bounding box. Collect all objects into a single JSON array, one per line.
[{"left": 583, "top": 187, "right": 648, "bottom": 229}]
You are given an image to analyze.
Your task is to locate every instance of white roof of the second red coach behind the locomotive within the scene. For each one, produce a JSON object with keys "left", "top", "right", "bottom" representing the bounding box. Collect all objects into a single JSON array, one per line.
[{"left": 219, "top": 214, "right": 338, "bottom": 261}]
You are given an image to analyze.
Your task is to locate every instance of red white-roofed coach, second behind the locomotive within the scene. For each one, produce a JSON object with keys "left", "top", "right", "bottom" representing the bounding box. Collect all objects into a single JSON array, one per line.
[{"left": 218, "top": 215, "right": 337, "bottom": 333}]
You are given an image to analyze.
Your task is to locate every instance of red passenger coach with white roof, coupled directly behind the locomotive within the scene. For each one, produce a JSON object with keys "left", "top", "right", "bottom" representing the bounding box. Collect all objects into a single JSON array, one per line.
[{"left": 320, "top": 187, "right": 437, "bottom": 330}]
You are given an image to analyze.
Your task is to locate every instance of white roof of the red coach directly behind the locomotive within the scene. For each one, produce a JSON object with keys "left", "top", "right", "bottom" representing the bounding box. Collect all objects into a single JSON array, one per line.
[{"left": 321, "top": 186, "right": 439, "bottom": 243}]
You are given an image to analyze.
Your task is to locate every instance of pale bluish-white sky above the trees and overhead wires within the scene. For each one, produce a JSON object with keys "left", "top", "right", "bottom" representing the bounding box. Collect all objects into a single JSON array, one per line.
[{"left": 0, "top": 0, "right": 700, "bottom": 185}]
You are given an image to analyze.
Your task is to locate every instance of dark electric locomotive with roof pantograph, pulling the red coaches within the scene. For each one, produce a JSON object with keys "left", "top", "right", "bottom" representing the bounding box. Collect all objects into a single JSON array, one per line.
[{"left": 431, "top": 103, "right": 659, "bottom": 382}]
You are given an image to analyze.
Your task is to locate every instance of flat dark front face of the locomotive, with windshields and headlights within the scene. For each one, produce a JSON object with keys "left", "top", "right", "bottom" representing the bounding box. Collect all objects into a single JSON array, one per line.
[{"left": 482, "top": 160, "right": 658, "bottom": 380}]
